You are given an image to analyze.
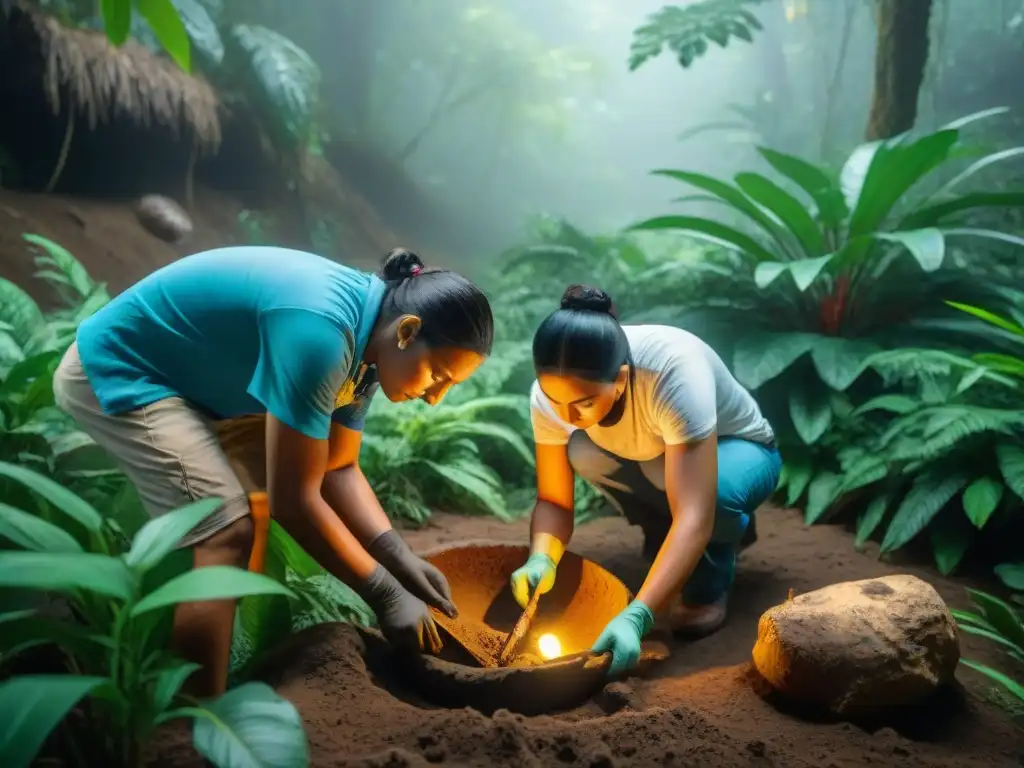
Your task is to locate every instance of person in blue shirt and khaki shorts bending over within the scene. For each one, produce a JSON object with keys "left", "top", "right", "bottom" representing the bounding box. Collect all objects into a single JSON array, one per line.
[{"left": 53, "top": 247, "right": 494, "bottom": 695}]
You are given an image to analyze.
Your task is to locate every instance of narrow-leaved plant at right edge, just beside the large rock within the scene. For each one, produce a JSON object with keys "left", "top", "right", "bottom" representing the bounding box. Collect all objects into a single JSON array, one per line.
[{"left": 952, "top": 563, "right": 1024, "bottom": 712}]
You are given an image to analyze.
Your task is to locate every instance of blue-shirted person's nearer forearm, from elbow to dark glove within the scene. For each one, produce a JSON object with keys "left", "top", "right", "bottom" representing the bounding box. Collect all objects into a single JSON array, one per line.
[{"left": 271, "top": 495, "right": 378, "bottom": 589}]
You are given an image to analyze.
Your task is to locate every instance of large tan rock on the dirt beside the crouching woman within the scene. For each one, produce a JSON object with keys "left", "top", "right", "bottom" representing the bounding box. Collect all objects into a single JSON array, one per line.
[{"left": 754, "top": 575, "right": 959, "bottom": 716}]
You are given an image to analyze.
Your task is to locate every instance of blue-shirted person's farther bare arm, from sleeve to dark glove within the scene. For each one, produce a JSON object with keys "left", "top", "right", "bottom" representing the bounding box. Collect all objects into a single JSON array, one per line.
[{"left": 323, "top": 424, "right": 392, "bottom": 547}]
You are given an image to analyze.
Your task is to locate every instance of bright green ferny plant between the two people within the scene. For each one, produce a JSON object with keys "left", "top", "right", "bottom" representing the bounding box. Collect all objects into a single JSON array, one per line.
[{"left": 359, "top": 395, "right": 534, "bottom": 523}]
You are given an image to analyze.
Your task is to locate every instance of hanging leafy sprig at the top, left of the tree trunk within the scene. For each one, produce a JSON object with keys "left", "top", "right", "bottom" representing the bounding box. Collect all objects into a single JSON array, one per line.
[{"left": 629, "top": 0, "right": 765, "bottom": 72}]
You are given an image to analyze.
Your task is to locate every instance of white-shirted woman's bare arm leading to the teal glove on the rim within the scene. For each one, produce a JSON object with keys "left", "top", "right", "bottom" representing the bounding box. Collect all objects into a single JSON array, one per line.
[{"left": 637, "top": 432, "right": 718, "bottom": 612}]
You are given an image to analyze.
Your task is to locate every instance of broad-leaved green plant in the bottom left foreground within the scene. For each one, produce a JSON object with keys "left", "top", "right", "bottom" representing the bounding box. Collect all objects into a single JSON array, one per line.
[{"left": 0, "top": 463, "right": 308, "bottom": 768}]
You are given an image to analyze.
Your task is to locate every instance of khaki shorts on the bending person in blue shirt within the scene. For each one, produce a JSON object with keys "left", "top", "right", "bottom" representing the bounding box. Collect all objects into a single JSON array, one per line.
[{"left": 53, "top": 344, "right": 266, "bottom": 547}]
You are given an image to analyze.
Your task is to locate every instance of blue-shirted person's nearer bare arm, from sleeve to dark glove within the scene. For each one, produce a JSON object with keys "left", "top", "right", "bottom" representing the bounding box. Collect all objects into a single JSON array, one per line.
[{"left": 266, "top": 414, "right": 378, "bottom": 587}]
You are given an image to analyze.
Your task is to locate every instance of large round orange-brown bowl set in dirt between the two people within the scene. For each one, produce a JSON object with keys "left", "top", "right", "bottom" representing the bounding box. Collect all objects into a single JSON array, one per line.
[{"left": 368, "top": 543, "right": 667, "bottom": 715}]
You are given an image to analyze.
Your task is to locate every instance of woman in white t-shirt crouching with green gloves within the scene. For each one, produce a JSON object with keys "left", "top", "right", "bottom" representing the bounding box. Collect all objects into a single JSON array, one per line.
[{"left": 512, "top": 286, "right": 782, "bottom": 675}]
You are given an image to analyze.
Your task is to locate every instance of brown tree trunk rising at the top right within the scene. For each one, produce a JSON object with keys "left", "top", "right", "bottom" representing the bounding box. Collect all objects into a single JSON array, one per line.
[{"left": 866, "top": 0, "right": 932, "bottom": 141}]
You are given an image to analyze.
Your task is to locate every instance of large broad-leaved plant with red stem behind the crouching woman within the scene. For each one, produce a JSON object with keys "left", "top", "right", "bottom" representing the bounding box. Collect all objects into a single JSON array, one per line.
[{"left": 634, "top": 110, "right": 1024, "bottom": 518}]
